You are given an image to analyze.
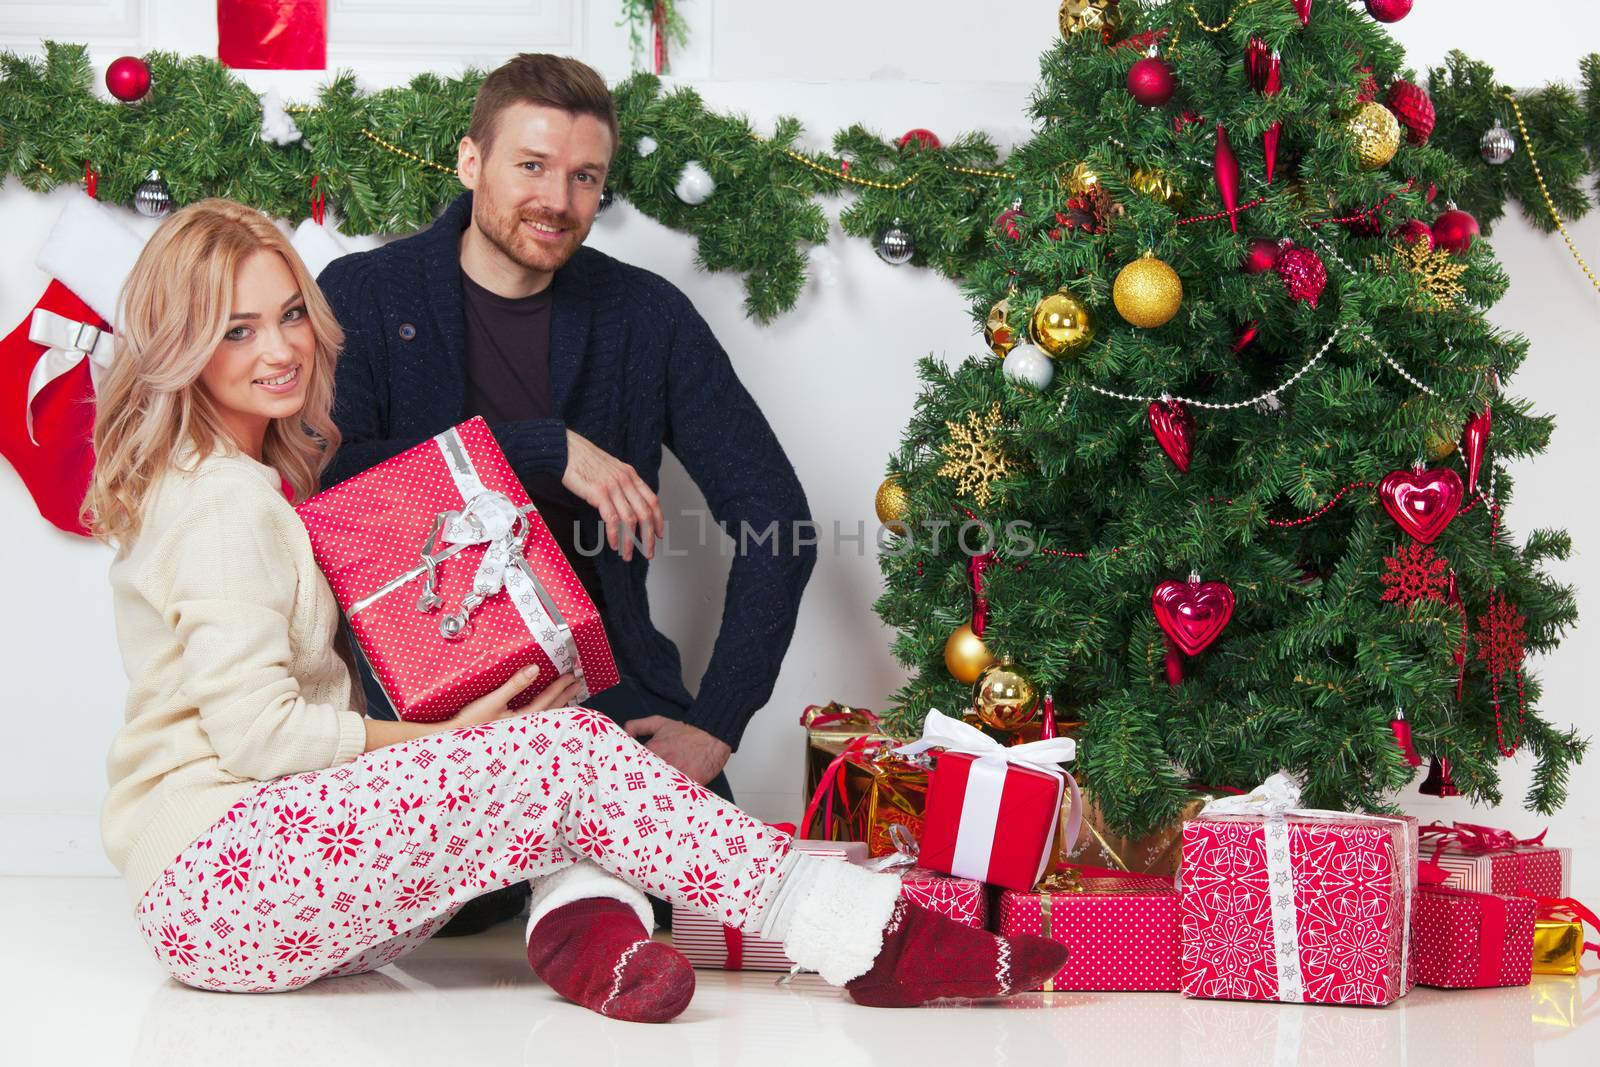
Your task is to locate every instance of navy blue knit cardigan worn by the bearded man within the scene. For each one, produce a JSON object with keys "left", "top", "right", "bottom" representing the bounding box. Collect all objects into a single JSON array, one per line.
[{"left": 318, "top": 192, "right": 816, "bottom": 747}]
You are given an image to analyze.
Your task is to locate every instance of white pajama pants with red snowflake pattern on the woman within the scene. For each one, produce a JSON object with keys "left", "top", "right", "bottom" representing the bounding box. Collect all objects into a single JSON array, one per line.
[{"left": 138, "top": 709, "right": 789, "bottom": 992}]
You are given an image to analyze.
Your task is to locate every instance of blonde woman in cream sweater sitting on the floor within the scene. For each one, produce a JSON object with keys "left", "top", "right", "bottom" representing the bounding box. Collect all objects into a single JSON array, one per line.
[{"left": 85, "top": 200, "right": 1064, "bottom": 1021}]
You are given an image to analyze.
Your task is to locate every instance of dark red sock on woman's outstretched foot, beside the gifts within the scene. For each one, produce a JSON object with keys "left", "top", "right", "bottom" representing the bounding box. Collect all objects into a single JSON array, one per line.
[{"left": 845, "top": 901, "right": 1067, "bottom": 1008}]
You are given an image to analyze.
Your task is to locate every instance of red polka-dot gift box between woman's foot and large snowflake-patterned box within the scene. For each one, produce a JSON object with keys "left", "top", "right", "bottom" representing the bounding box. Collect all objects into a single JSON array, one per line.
[{"left": 997, "top": 869, "right": 1178, "bottom": 992}]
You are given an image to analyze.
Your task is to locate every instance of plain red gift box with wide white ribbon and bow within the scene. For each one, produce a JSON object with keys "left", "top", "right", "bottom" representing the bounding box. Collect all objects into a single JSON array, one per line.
[{"left": 896, "top": 709, "right": 1083, "bottom": 893}]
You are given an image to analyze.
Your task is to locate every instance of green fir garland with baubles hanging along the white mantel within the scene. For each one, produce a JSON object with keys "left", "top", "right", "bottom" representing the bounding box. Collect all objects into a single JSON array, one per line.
[{"left": 9, "top": 42, "right": 1600, "bottom": 323}]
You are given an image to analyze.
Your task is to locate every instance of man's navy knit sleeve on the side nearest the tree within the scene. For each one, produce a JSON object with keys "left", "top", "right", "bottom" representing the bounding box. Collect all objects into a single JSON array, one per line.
[{"left": 666, "top": 294, "right": 816, "bottom": 749}]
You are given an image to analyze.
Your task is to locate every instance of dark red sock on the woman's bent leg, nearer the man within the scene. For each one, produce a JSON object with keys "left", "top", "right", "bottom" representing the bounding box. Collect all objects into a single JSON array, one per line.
[{"left": 528, "top": 897, "right": 694, "bottom": 1022}]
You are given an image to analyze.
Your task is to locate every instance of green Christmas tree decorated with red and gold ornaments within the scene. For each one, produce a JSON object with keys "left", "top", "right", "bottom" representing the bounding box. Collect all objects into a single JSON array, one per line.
[{"left": 877, "top": 0, "right": 1584, "bottom": 832}]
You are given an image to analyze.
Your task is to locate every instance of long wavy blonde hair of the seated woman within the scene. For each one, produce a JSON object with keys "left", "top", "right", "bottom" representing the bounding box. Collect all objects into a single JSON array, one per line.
[{"left": 83, "top": 198, "right": 344, "bottom": 544}]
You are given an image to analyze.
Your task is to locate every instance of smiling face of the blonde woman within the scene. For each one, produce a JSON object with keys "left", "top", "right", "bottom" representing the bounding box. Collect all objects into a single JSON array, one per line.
[{"left": 200, "top": 248, "right": 317, "bottom": 459}]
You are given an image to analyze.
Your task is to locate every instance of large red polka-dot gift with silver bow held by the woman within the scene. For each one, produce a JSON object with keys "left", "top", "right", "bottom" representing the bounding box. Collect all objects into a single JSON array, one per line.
[{"left": 294, "top": 419, "right": 618, "bottom": 723}]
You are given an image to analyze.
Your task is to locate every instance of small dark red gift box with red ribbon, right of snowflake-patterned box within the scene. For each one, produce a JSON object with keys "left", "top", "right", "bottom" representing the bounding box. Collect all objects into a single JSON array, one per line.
[{"left": 1411, "top": 885, "right": 1536, "bottom": 989}]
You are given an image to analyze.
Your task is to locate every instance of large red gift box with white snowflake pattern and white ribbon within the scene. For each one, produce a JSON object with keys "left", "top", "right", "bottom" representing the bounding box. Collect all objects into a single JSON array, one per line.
[{"left": 1179, "top": 774, "right": 1418, "bottom": 1005}]
